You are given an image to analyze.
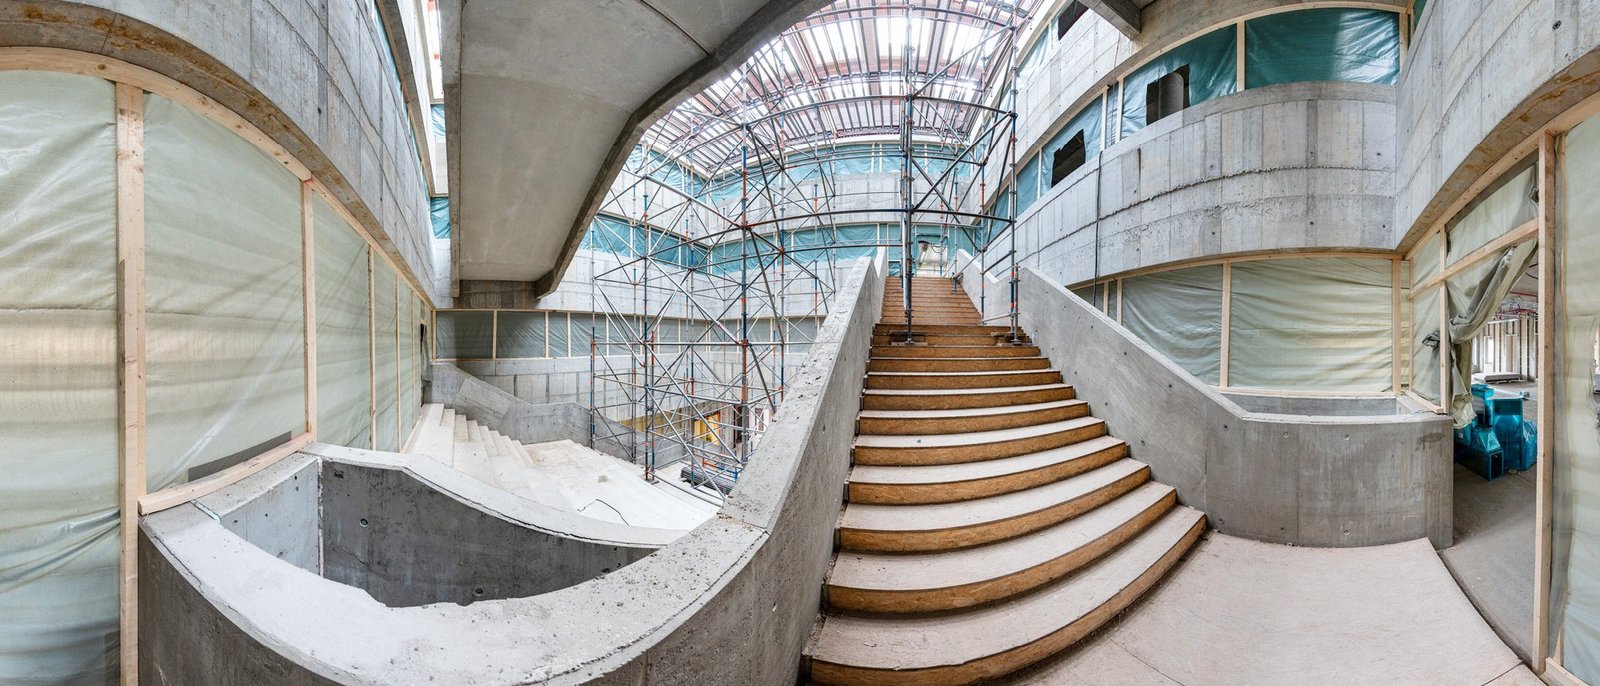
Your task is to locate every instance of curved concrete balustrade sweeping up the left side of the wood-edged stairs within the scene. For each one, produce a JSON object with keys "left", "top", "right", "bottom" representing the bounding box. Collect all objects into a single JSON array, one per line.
[{"left": 139, "top": 261, "right": 883, "bottom": 684}]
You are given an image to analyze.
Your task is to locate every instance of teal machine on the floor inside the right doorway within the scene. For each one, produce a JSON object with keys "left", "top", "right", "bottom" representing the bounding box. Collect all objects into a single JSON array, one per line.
[{"left": 1456, "top": 378, "right": 1538, "bottom": 481}]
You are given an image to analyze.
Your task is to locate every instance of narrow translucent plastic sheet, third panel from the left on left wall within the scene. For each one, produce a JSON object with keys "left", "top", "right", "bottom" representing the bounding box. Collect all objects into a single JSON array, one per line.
[{"left": 310, "top": 195, "right": 373, "bottom": 448}]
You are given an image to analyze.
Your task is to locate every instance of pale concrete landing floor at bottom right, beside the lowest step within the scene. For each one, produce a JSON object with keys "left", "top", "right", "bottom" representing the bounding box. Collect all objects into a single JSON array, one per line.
[{"left": 1010, "top": 532, "right": 1541, "bottom": 686}]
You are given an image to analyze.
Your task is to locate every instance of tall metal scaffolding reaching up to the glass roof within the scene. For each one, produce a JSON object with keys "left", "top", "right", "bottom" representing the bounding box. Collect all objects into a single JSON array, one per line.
[{"left": 589, "top": 0, "right": 1027, "bottom": 494}]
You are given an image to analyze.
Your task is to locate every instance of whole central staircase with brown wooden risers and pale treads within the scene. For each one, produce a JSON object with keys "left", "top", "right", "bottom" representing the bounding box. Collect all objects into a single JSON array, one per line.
[{"left": 806, "top": 278, "right": 1205, "bottom": 684}]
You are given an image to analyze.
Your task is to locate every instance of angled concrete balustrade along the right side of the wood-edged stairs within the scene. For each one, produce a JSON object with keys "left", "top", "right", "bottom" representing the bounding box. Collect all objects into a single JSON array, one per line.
[{"left": 963, "top": 269, "right": 1453, "bottom": 547}]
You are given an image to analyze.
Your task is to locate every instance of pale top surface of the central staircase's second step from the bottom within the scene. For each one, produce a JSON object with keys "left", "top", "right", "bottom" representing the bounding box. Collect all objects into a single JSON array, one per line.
[{"left": 827, "top": 481, "right": 1174, "bottom": 592}]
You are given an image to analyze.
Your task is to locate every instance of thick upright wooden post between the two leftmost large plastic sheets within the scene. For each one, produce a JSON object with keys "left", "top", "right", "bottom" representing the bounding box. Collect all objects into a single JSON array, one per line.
[{"left": 117, "top": 83, "right": 147, "bottom": 686}]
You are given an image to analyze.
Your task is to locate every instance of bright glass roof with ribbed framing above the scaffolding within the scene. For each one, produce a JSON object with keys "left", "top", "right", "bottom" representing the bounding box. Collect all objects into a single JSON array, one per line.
[{"left": 643, "top": 0, "right": 1038, "bottom": 176}]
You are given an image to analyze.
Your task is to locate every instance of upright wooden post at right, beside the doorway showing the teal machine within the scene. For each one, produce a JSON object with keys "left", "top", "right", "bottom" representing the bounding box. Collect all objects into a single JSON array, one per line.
[{"left": 1531, "top": 131, "right": 1573, "bottom": 675}]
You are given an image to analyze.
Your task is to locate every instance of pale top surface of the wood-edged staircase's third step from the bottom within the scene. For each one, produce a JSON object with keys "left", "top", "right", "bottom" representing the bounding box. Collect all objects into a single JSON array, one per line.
[{"left": 838, "top": 457, "right": 1149, "bottom": 531}]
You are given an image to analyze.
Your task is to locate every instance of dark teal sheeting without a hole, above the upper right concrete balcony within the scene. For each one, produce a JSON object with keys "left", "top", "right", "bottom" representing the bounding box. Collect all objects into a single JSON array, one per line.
[{"left": 1245, "top": 8, "right": 1400, "bottom": 88}]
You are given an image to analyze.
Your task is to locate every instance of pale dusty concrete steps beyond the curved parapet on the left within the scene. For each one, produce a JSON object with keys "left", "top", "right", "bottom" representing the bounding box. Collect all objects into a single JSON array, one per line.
[{"left": 405, "top": 405, "right": 718, "bottom": 531}]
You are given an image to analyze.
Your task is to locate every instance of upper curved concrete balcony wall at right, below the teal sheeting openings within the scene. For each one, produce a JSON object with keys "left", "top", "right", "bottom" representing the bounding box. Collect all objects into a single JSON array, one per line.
[{"left": 1000, "top": 82, "right": 1395, "bottom": 283}]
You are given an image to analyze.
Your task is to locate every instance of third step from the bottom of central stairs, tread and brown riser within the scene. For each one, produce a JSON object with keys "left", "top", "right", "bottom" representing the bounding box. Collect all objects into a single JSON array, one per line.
[{"left": 838, "top": 457, "right": 1150, "bottom": 553}]
